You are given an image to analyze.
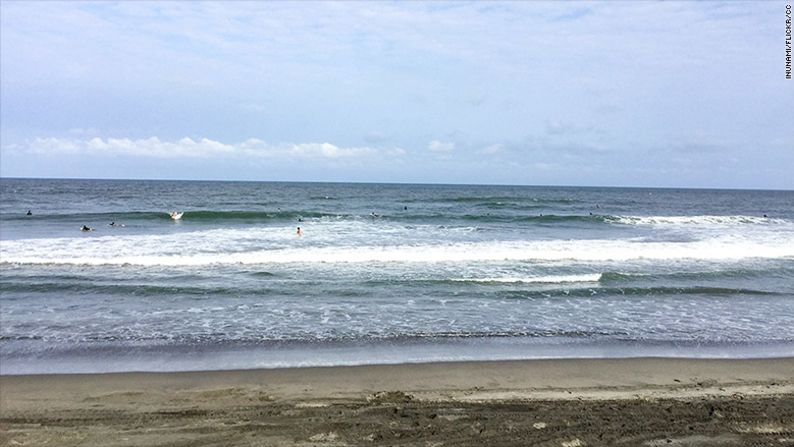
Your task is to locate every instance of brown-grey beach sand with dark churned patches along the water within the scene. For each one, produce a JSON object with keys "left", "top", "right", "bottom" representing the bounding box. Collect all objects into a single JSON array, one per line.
[{"left": 0, "top": 358, "right": 794, "bottom": 447}]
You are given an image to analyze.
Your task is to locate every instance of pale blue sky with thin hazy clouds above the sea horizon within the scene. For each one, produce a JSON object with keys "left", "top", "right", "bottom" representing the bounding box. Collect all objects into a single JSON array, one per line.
[{"left": 0, "top": 0, "right": 794, "bottom": 189}]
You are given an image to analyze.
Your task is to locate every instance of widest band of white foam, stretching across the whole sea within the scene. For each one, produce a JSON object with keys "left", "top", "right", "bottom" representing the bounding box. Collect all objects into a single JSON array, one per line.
[{"left": 0, "top": 232, "right": 794, "bottom": 266}]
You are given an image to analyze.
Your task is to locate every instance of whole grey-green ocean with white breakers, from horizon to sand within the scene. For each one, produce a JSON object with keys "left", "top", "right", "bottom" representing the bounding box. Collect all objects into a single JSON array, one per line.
[{"left": 0, "top": 179, "right": 794, "bottom": 374}]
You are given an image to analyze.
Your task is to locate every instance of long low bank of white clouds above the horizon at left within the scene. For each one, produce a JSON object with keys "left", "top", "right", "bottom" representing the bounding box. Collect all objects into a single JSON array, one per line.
[{"left": 22, "top": 137, "right": 394, "bottom": 159}]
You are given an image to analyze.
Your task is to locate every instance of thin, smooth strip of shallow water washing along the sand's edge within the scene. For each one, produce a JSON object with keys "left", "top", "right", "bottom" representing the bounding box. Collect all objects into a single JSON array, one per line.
[{"left": 6, "top": 336, "right": 794, "bottom": 376}]
